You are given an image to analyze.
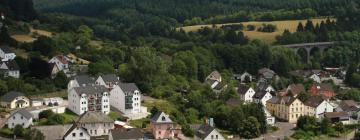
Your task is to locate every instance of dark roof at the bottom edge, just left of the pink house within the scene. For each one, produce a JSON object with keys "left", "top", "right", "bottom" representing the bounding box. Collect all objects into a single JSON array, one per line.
[{"left": 111, "top": 128, "right": 144, "bottom": 140}]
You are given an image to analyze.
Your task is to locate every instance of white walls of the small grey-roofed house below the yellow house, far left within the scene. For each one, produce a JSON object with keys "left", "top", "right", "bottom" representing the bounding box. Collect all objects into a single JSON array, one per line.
[{"left": 6, "top": 113, "right": 33, "bottom": 128}]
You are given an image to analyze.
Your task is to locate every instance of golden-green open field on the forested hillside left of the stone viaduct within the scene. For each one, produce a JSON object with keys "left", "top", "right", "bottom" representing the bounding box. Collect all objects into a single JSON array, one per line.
[{"left": 178, "top": 18, "right": 335, "bottom": 44}]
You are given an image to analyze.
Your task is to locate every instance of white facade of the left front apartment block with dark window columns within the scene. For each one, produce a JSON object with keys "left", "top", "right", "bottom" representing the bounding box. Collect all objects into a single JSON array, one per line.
[{"left": 68, "top": 87, "right": 110, "bottom": 115}]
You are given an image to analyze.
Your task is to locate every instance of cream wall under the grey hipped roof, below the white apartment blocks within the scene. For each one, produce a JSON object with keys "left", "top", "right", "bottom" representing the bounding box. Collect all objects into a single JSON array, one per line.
[{"left": 80, "top": 123, "right": 114, "bottom": 136}]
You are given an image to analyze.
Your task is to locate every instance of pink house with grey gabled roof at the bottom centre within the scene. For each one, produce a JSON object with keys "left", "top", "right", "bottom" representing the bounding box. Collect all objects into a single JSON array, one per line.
[{"left": 150, "top": 112, "right": 181, "bottom": 139}]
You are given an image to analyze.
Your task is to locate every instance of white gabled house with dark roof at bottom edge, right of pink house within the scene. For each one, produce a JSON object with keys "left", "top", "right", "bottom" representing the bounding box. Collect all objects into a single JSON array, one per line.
[{"left": 193, "top": 124, "right": 225, "bottom": 140}]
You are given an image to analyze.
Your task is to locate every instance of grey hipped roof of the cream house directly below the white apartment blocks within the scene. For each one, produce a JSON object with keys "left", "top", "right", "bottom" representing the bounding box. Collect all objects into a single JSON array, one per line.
[{"left": 77, "top": 112, "right": 114, "bottom": 123}]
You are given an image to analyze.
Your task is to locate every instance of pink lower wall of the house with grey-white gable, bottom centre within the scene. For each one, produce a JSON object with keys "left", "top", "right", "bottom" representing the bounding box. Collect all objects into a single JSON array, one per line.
[{"left": 150, "top": 122, "right": 174, "bottom": 139}]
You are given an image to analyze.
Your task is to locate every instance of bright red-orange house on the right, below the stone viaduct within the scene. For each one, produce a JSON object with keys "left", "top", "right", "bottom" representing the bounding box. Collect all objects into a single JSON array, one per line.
[{"left": 308, "top": 83, "right": 336, "bottom": 98}]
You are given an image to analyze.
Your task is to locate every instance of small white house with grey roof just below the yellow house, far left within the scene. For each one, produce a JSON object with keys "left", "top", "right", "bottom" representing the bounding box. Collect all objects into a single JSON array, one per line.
[{"left": 6, "top": 109, "right": 33, "bottom": 128}]
